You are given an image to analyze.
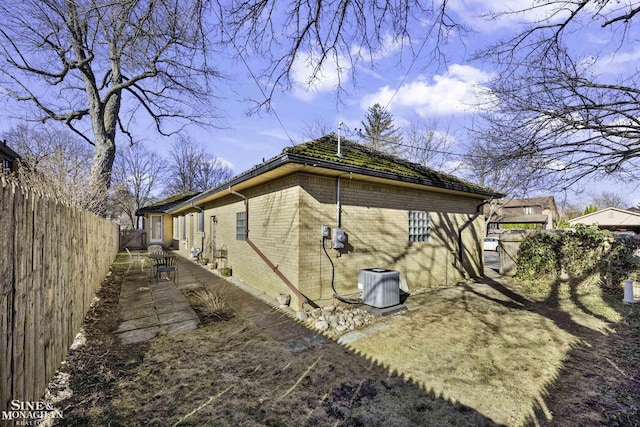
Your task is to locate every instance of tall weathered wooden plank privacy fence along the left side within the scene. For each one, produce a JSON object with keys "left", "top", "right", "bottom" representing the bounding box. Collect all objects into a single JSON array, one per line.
[{"left": 0, "top": 177, "right": 118, "bottom": 418}]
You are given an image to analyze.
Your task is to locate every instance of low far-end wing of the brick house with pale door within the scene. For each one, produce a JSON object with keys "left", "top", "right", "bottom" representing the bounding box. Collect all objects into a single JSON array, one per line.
[{"left": 136, "top": 192, "right": 198, "bottom": 249}]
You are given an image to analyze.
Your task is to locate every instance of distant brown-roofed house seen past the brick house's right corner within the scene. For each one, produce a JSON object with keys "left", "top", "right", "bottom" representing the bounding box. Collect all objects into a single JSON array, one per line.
[{"left": 485, "top": 196, "right": 559, "bottom": 234}]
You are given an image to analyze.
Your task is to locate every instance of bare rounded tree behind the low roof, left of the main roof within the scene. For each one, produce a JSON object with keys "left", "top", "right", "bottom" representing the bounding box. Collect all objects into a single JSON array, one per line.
[{"left": 165, "top": 136, "right": 233, "bottom": 194}]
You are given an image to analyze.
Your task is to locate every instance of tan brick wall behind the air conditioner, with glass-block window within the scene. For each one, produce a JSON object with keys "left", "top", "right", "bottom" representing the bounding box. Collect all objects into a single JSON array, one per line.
[{"left": 300, "top": 176, "right": 484, "bottom": 302}]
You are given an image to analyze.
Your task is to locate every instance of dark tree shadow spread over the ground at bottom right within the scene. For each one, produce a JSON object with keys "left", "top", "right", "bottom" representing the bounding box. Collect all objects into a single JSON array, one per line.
[{"left": 472, "top": 272, "right": 640, "bottom": 425}]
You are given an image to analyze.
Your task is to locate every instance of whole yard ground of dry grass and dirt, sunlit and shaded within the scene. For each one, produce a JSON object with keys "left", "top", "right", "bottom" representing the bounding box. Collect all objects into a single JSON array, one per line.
[{"left": 45, "top": 267, "right": 640, "bottom": 426}]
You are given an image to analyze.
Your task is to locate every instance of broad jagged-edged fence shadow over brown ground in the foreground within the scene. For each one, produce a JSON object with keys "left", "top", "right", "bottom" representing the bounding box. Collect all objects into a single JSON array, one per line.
[{"left": 48, "top": 256, "right": 504, "bottom": 426}]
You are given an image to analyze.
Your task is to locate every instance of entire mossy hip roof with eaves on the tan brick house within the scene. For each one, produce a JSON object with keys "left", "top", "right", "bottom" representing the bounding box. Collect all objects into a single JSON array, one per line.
[{"left": 165, "top": 133, "right": 504, "bottom": 212}]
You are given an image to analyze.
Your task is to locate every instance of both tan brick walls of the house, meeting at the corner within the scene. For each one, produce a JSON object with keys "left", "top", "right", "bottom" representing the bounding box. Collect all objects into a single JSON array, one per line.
[{"left": 170, "top": 174, "right": 484, "bottom": 309}]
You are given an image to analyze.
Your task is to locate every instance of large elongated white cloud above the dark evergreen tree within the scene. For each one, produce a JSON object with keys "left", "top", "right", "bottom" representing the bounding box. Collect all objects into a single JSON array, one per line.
[{"left": 360, "top": 64, "right": 492, "bottom": 117}]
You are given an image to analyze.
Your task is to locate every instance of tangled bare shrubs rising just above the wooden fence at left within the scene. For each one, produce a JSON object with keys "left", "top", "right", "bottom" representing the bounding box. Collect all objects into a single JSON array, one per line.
[{"left": 2, "top": 125, "right": 107, "bottom": 212}]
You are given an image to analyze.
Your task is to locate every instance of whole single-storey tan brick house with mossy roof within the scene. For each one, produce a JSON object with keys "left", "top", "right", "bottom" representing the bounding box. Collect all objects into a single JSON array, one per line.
[{"left": 141, "top": 134, "right": 503, "bottom": 309}]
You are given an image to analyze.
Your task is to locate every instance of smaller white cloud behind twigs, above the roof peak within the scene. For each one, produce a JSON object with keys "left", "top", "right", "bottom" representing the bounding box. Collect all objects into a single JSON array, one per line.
[{"left": 291, "top": 53, "right": 350, "bottom": 101}]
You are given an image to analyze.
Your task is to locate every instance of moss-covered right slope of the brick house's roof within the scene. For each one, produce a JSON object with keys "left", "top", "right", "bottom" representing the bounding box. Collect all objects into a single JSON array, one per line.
[{"left": 283, "top": 133, "right": 493, "bottom": 193}]
